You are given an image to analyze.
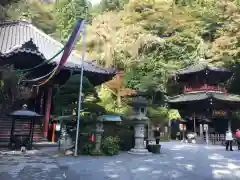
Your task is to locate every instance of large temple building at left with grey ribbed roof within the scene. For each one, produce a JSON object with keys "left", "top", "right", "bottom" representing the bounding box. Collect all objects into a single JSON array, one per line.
[{"left": 0, "top": 21, "right": 116, "bottom": 142}]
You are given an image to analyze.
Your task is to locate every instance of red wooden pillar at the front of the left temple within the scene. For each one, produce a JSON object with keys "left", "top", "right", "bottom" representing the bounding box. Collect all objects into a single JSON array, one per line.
[{"left": 44, "top": 87, "right": 52, "bottom": 137}]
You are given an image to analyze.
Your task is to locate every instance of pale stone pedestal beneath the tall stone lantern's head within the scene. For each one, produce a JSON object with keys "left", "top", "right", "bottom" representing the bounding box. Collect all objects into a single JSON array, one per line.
[{"left": 128, "top": 119, "right": 151, "bottom": 155}]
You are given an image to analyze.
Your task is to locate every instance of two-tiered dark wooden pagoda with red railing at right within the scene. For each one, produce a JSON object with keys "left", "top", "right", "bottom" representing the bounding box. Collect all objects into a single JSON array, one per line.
[{"left": 168, "top": 62, "right": 240, "bottom": 140}]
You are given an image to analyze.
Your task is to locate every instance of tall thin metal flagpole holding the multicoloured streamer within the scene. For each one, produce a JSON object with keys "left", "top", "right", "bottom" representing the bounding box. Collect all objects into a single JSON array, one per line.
[{"left": 74, "top": 20, "right": 86, "bottom": 156}]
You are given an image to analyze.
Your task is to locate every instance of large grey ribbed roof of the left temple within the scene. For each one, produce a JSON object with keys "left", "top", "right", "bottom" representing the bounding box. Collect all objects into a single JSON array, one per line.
[{"left": 0, "top": 21, "right": 115, "bottom": 74}]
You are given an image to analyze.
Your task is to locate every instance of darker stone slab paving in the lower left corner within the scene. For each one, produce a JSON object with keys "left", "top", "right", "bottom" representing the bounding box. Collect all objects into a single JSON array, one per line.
[{"left": 0, "top": 148, "right": 77, "bottom": 180}]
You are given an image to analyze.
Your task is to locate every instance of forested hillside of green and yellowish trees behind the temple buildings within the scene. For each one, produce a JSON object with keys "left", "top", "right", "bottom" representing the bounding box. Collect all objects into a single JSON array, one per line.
[{"left": 1, "top": 0, "right": 240, "bottom": 121}]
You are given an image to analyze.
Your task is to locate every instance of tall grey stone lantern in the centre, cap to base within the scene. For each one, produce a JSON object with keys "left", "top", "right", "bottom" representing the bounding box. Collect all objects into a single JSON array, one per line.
[{"left": 128, "top": 94, "right": 151, "bottom": 155}]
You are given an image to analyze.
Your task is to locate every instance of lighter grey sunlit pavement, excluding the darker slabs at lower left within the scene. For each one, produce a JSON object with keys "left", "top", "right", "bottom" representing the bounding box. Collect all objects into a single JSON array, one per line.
[{"left": 59, "top": 142, "right": 240, "bottom": 180}]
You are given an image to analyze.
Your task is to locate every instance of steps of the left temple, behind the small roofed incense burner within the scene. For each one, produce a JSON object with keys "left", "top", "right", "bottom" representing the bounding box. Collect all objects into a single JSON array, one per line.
[{"left": 0, "top": 115, "right": 45, "bottom": 145}]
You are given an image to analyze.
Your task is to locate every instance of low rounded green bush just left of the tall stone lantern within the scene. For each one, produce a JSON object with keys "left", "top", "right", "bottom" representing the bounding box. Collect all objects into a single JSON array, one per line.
[{"left": 102, "top": 136, "right": 120, "bottom": 156}]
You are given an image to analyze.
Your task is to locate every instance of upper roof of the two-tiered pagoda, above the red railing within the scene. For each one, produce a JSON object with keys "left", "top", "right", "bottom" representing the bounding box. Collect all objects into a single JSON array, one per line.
[{"left": 177, "top": 62, "right": 231, "bottom": 75}]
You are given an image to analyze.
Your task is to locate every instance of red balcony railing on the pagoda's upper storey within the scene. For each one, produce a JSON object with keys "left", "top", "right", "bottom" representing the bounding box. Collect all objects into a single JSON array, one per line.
[{"left": 184, "top": 84, "right": 227, "bottom": 93}]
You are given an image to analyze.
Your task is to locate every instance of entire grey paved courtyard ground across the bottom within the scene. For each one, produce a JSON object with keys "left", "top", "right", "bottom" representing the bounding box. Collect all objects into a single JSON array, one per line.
[{"left": 0, "top": 142, "right": 240, "bottom": 180}]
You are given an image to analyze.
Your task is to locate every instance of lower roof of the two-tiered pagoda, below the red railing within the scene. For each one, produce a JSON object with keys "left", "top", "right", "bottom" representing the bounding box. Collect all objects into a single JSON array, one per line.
[{"left": 168, "top": 91, "right": 240, "bottom": 104}]
